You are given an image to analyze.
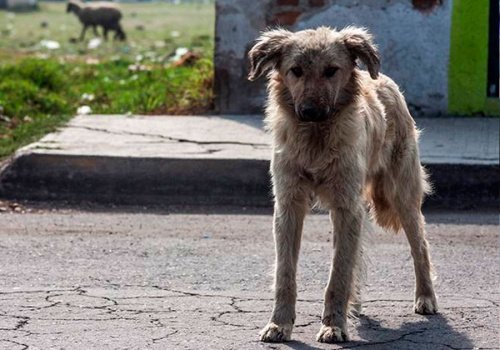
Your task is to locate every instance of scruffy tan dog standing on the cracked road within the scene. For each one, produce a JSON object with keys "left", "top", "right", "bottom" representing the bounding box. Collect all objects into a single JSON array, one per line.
[{"left": 249, "top": 27, "right": 437, "bottom": 343}]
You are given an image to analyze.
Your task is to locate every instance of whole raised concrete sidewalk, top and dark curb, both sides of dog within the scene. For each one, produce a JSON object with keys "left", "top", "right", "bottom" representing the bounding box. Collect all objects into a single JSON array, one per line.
[{"left": 0, "top": 115, "right": 500, "bottom": 208}]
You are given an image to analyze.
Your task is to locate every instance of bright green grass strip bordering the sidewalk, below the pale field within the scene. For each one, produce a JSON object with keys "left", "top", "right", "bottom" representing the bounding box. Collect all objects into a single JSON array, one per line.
[{"left": 0, "top": 58, "right": 213, "bottom": 158}]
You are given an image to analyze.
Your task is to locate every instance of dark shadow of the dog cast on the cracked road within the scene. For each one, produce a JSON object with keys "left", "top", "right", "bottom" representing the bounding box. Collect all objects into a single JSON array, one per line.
[{"left": 283, "top": 314, "right": 474, "bottom": 350}]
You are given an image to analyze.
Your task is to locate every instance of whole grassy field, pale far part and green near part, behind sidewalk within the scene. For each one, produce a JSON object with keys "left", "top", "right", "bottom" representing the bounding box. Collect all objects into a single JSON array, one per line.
[{"left": 0, "top": 2, "right": 215, "bottom": 159}]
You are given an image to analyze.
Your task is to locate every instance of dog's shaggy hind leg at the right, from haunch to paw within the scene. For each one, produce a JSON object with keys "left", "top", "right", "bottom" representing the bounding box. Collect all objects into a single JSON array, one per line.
[{"left": 374, "top": 80, "right": 437, "bottom": 314}]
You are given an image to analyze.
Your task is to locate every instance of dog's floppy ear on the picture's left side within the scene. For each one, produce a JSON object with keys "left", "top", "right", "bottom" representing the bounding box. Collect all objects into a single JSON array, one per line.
[{"left": 248, "top": 29, "right": 293, "bottom": 80}]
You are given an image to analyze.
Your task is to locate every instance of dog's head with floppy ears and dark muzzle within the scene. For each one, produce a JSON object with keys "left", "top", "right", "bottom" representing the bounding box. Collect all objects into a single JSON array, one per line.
[{"left": 248, "top": 27, "right": 380, "bottom": 122}]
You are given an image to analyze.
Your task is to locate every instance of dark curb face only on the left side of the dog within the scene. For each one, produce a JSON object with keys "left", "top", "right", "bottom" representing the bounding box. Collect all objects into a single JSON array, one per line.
[{"left": 0, "top": 154, "right": 271, "bottom": 206}]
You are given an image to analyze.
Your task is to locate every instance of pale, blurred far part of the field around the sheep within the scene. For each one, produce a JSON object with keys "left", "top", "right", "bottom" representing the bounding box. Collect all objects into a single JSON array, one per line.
[{"left": 0, "top": 2, "right": 215, "bottom": 59}]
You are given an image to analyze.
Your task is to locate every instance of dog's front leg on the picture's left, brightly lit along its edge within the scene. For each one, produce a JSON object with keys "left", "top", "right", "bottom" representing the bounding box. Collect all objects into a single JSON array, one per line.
[{"left": 260, "top": 186, "right": 306, "bottom": 342}]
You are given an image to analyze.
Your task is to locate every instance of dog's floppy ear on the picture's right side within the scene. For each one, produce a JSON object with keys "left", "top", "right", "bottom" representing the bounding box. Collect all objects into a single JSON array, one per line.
[{"left": 340, "top": 27, "right": 380, "bottom": 79}]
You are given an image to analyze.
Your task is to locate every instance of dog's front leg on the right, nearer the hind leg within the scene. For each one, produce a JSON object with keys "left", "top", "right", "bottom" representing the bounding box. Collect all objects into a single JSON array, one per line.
[{"left": 317, "top": 205, "right": 364, "bottom": 343}]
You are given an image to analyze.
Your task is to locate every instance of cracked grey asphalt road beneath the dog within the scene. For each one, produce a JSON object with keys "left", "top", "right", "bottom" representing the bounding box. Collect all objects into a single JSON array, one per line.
[{"left": 0, "top": 208, "right": 500, "bottom": 350}]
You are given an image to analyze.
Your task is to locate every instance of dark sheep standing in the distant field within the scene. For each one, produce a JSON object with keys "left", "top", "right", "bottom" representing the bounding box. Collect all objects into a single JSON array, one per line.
[{"left": 66, "top": 0, "right": 126, "bottom": 40}]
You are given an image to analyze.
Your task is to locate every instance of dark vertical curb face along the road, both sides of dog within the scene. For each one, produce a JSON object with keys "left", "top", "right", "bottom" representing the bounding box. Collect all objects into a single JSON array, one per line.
[{"left": 0, "top": 154, "right": 500, "bottom": 209}]
